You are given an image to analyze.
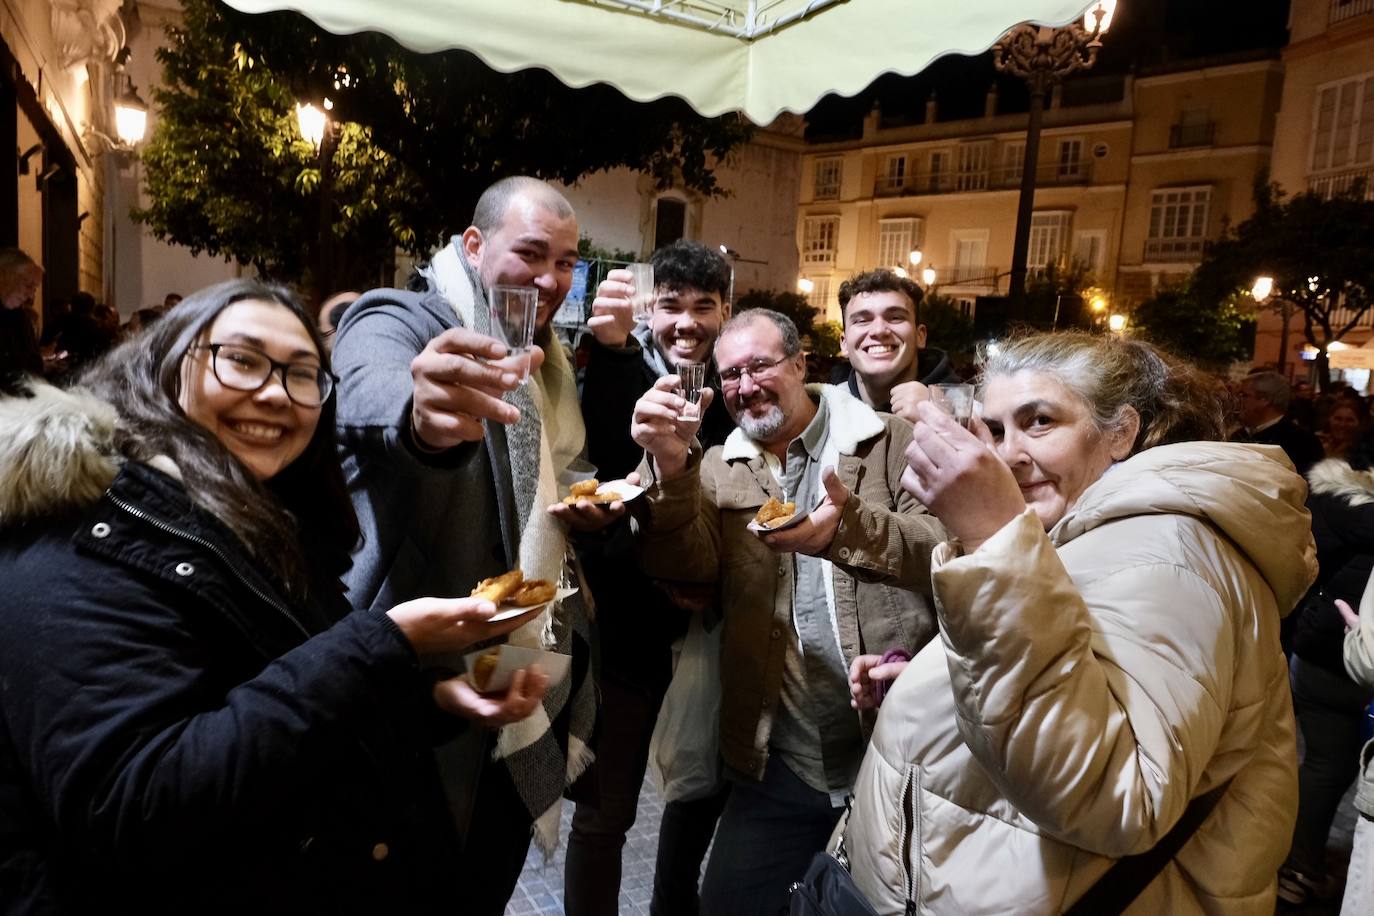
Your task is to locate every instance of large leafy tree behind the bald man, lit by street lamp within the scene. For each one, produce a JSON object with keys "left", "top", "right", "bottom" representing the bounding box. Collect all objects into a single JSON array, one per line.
[{"left": 135, "top": 0, "right": 750, "bottom": 300}]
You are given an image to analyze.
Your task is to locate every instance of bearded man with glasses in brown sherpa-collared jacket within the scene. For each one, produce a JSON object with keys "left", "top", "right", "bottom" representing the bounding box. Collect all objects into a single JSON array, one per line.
[{"left": 631, "top": 309, "right": 944, "bottom": 916}]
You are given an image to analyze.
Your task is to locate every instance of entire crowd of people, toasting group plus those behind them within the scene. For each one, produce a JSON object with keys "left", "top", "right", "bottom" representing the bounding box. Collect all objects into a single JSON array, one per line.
[{"left": 0, "top": 177, "right": 1374, "bottom": 916}]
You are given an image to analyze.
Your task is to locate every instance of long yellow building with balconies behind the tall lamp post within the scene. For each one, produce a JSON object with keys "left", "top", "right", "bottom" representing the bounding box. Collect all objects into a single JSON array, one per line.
[{"left": 797, "top": 54, "right": 1282, "bottom": 325}]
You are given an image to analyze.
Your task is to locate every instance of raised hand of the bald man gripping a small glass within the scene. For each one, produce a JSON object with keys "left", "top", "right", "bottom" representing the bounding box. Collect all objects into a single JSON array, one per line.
[{"left": 411, "top": 328, "right": 544, "bottom": 452}]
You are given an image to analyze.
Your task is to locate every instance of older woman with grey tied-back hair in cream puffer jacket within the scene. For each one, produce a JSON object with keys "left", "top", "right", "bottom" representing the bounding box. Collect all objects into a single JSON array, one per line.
[{"left": 844, "top": 334, "right": 1316, "bottom": 916}]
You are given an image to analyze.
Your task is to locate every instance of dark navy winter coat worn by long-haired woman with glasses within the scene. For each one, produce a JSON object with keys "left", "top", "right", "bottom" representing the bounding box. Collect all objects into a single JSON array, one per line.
[{"left": 0, "top": 464, "right": 460, "bottom": 915}]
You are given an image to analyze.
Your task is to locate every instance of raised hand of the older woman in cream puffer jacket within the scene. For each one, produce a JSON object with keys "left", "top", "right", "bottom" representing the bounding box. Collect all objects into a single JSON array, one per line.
[{"left": 901, "top": 401, "right": 1026, "bottom": 553}]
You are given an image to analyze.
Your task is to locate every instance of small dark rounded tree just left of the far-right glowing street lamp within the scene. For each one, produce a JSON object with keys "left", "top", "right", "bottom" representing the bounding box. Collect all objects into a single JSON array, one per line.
[{"left": 1131, "top": 283, "right": 1254, "bottom": 368}]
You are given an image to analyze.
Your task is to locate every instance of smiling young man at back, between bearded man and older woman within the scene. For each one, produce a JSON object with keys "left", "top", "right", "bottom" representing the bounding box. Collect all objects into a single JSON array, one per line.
[{"left": 840, "top": 269, "right": 959, "bottom": 423}]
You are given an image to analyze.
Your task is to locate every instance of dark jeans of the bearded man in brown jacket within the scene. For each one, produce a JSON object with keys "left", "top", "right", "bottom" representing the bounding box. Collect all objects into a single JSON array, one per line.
[{"left": 701, "top": 754, "right": 844, "bottom": 916}]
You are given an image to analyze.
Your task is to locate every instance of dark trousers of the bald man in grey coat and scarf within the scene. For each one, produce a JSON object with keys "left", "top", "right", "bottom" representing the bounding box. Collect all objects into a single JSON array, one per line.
[{"left": 453, "top": 758, "right": 533, "bottom": 916}]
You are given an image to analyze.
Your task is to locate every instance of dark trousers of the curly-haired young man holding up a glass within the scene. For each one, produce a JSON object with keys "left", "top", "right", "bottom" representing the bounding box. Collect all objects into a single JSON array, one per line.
[{"left": 563, "top": 677, "right": 724, "bottom": 916}]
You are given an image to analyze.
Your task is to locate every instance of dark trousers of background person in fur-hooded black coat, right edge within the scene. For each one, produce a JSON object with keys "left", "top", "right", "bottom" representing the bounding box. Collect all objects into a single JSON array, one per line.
[{"left": 1287, "top": 656, "right": 1370, "bottom": 875}]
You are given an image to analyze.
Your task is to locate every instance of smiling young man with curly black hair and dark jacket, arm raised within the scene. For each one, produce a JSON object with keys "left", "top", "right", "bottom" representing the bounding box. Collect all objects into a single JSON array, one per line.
[{"left": 563, "top": 239, "right": 734, "bottom": 916}]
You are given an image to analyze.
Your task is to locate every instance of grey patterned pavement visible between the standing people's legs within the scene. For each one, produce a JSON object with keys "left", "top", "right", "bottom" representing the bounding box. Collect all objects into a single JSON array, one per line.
[{"left": 506, "top": 777, "right": 664, "bottom": 916}]
